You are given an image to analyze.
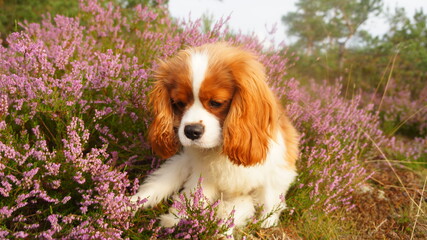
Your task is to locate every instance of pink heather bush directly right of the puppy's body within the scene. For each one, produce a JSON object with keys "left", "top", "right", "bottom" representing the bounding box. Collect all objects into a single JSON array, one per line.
[{"left": 282, "top": 82, "right": 386, "bottom": 216}]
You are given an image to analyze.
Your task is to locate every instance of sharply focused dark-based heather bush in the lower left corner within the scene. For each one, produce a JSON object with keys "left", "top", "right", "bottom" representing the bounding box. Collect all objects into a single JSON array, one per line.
[{"left": 0, "top": 117, "right": 135, "bottom": 239}]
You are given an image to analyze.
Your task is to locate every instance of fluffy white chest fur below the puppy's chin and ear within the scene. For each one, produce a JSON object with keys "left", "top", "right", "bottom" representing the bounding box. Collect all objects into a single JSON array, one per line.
[{"left": 184, "top": 129, "right": 296, "bottom": 201}]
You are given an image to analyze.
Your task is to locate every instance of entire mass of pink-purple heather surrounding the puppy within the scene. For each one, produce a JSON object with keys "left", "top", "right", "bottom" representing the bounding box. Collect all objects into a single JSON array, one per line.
[{"left": 0, "top": 0, "right": 422, "bottom": 239}]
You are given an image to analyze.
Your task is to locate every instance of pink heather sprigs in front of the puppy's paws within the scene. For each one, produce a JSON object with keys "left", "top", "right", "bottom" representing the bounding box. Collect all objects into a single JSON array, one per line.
[{"left": 126, "top": 178, "right": 234, "bottom": 239}]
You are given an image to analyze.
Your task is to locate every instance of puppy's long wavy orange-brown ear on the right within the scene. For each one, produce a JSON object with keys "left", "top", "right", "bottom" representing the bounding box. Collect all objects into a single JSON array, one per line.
[{"left": 223, "top": 51, "right": 278, "bottom": 166}]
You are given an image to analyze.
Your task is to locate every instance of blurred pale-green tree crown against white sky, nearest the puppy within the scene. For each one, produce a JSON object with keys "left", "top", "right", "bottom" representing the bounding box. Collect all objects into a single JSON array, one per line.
[{"left": 282, "top": 0, "right": 382, "bottom": 55}]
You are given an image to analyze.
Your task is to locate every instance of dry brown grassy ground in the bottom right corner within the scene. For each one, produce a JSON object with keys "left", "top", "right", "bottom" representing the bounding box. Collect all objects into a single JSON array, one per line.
[{"left": 348, "top": 161, "right": 427, "bottom": 239}]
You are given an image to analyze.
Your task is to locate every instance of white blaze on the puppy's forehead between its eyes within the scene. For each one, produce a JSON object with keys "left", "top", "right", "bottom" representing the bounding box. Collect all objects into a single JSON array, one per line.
[{"left": 190, "top": 52, "right": 209, "bottom": 101}]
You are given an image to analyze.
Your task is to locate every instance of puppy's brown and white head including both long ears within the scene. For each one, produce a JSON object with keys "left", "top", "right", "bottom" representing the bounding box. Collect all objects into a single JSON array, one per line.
[{"left": 149, "top": 43, "right": 277, "bottom": 166}]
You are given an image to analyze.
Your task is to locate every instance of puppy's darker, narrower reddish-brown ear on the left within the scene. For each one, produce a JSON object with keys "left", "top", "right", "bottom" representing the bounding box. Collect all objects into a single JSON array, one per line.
[{"left": 148, "top": 65, "right": 179, "bottom": 158}]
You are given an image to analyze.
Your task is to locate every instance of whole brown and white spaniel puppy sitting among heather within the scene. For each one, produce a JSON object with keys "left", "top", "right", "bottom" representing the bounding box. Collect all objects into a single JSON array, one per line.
[{"left": 131, "top": 43, "right": 299, "bottom": 231}]
